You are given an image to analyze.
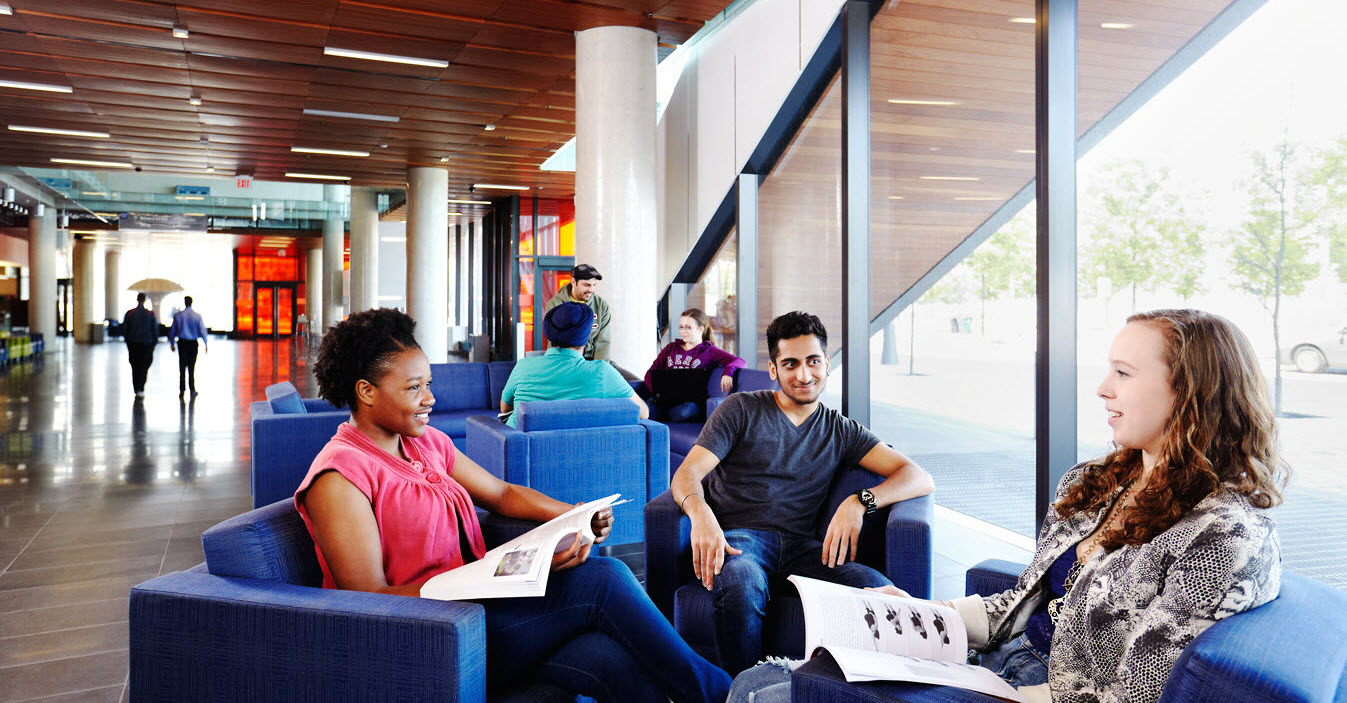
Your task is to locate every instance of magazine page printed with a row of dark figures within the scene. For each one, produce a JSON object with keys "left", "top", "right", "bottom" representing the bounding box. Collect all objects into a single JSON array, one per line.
[{"left": 789, "top": 576, "right": 968, "bottom": 664}]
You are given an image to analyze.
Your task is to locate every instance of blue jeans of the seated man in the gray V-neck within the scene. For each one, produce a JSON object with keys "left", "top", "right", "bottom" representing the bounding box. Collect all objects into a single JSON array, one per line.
[{"left": 711, "top": 528, "right": 893, "bottom": 676}]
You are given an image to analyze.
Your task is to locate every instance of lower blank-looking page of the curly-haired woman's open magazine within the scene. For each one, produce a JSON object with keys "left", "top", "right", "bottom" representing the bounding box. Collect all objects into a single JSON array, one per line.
[{"left": 823, "top": 646, "right": 1026, "bottom": 703}]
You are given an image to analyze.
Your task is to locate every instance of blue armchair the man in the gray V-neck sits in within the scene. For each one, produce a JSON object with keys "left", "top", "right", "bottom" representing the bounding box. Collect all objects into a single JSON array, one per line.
[{"left": 645, "top": 467, "right": 935, "bottom": 661}]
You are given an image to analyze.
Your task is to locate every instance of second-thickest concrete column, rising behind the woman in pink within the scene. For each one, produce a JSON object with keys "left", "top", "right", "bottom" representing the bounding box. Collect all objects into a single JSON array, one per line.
[{"left": 407, "top": 167, "right": 449, "bottom": 364}]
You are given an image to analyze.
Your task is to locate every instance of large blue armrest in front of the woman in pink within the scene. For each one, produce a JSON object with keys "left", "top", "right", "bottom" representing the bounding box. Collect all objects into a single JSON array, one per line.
[{"left": 129, "top": 572, "right": 486, "bottom": 702}]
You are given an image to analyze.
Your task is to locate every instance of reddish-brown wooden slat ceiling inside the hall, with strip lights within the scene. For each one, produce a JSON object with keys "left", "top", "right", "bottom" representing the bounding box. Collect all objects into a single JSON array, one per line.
[{"left": 0, "top": 0, "right": 729, "bottom": 197}]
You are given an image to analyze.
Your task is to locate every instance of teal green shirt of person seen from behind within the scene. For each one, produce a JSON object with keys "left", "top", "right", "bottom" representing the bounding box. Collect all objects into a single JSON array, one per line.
[{"left": 501, "top": 346, "right": 633, "bottom": 427}]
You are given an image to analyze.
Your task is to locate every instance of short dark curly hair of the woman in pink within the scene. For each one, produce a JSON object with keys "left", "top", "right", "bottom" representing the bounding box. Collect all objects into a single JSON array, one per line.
[{"left": 314, "top": 307, "right": 420, "bottom": 408}]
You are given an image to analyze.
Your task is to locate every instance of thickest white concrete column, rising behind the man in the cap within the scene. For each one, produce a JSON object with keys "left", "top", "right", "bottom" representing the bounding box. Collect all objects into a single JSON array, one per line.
[{"left": 575, "top": 27, "right": 659, "bottom": 372}]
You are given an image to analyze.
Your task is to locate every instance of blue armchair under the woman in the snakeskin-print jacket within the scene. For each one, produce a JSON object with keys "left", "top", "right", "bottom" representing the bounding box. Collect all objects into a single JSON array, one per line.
[{"left": 791, "top": 560, "right": 1347, "bottom": 703}]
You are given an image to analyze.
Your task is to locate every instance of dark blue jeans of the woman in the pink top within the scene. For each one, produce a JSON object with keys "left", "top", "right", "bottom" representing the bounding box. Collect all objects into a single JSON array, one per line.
[{"left": 482, "top": 556, "right": 730, "bottom": 703}]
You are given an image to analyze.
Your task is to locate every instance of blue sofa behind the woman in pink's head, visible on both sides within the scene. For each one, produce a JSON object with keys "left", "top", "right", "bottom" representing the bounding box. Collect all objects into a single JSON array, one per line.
[{"left": 249, "top": 361, "right": 515, "bottom": 508}]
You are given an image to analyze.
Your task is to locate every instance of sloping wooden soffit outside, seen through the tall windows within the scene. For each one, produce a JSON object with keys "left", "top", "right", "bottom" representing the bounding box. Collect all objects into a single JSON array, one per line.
[{"left": 758, "top": 0, "right": 1228, "bottom": 350}]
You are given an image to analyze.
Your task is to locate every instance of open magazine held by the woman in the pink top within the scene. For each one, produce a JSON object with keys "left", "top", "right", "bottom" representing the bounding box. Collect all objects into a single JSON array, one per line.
[{"left": 422, "top": 493, "right": 626, "bottom": 601}]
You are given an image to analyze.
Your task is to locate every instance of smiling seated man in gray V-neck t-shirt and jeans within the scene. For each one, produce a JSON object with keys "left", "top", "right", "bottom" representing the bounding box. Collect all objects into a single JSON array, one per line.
[{"left": 671, "top": 311, "right": 933, "bottom": 675}]
